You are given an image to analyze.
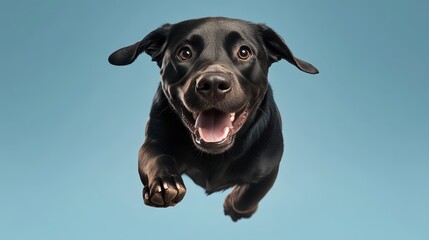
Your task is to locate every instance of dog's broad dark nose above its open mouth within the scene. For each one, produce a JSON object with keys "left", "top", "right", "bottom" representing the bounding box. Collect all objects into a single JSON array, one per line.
[{"left": 195, "top": 73, "right": 231, "bottom": 99}]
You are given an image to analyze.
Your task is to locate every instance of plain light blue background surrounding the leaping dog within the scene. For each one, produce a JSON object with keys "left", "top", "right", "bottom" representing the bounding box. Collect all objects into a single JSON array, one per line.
[{"left": 0, "top": 0, "right": 429, "bottom": 240}]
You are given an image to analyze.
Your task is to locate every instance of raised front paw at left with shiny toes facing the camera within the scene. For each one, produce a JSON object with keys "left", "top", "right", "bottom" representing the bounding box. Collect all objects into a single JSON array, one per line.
[{"left": 143, "top": 175, "right": 186, "bottom": 207}]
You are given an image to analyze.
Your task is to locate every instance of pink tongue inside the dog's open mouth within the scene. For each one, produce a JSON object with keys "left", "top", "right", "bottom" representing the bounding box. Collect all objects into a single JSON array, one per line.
[{"left": 195, "top": 109, "right": 232, "bottom": 142}]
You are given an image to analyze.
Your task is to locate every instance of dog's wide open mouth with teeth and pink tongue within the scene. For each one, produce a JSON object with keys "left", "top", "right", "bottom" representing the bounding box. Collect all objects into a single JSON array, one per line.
[{"left": 183, "top": 108, "right": 248, "bottom": 148}]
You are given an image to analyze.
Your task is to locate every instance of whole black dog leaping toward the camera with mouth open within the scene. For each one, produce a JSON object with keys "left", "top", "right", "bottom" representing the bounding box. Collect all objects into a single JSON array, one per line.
[{"left": 109, "top": 17, "right": 318, "bottom": 221}]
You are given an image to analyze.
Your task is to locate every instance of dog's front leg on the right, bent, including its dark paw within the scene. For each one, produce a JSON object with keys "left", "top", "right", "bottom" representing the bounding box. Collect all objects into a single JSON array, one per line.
[{"left": 223, "top": 167, "right": 278, "bottom": 222}]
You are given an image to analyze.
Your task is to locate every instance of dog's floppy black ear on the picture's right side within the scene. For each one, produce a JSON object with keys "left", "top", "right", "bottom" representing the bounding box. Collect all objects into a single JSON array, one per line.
[{"left": 259, "top": 24, "right": 319, "bottom": 74}]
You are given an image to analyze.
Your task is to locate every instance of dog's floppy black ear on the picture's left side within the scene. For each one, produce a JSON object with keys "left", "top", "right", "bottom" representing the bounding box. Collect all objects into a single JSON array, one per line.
[{"left": 109, "top": 24, "right": 171, "bottom": 66}]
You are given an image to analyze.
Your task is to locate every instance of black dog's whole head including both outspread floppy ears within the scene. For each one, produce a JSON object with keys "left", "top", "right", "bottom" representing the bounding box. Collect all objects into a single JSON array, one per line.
[{"left": 109, "top": 18, "right": 318, "bottom": 154}]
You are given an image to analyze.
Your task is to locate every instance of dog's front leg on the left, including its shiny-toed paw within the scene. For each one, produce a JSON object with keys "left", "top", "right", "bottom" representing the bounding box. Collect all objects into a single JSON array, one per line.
[{"left": 138, "top": 139, "right": 186, "bottom": 207}]
